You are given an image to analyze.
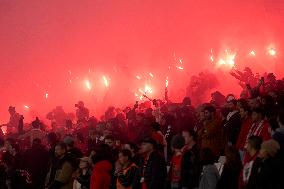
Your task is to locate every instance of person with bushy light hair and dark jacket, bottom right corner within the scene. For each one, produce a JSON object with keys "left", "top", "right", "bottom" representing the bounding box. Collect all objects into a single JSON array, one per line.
[{"left": 247, "top": 139, "right": 283, "bottom": 189}]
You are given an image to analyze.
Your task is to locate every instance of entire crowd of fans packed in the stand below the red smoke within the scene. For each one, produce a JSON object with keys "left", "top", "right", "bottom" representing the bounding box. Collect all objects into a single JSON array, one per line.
[{"left": 0, "top": 72, "right": 284, "bottom": 189}]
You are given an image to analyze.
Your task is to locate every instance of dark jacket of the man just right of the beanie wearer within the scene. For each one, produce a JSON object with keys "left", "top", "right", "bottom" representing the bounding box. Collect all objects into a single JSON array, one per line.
[{"left": 180, "top": 144, "right": 202, "bottom": 189}]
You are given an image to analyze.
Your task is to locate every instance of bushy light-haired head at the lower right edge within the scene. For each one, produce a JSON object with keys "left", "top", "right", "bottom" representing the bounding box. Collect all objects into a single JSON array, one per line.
[{"left": 259, "top": 139, "right": 280, "bottom": 159}]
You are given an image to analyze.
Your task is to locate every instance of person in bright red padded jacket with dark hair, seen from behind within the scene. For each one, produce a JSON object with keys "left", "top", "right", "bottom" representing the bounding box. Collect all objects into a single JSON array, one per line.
[{"left": 90, "top": 144, "right": 113, "bottom": 189}]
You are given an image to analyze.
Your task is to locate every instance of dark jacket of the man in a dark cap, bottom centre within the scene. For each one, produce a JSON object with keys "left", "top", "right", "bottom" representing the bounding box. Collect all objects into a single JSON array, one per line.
[{"left": 133, "top": 152, "right": 167, "bottom": 189}]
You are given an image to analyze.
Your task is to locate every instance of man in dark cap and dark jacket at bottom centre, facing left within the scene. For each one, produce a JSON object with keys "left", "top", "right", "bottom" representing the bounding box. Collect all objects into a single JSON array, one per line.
[{"left": 133, "top": 138, "right": 167, "bottom": 189}]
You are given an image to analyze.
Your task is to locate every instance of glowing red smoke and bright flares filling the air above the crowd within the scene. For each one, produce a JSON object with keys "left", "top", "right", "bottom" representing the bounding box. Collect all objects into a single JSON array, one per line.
[{"left": 0, "top": 0, "right": 284, "bottom": 122}]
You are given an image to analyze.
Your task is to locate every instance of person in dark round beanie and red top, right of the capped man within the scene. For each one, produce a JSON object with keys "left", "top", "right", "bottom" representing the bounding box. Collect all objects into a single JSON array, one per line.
[{"left": 168, "top": 135, "right": 185, "bottom": 189}]
